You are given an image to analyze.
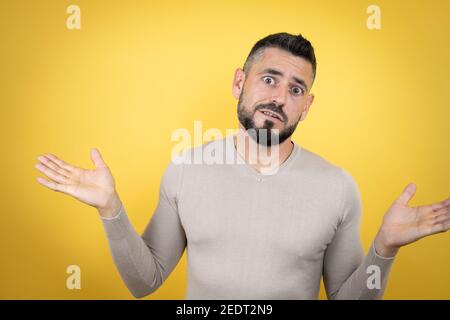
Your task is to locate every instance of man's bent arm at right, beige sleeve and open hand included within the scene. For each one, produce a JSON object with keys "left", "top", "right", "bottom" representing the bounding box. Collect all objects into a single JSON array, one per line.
[{"left": 324, "top": 172, "right": 450, "bottom": 299}]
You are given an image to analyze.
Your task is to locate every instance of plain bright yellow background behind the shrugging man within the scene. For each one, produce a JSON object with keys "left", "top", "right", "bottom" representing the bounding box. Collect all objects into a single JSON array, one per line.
[{"left": 0, "top": 0, "right": 450, "bottom": 299}]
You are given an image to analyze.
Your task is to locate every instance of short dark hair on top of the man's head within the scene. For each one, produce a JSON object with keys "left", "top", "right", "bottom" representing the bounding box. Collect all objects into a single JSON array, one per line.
[{"left": 244, "top": 32, "right": 316, "bottom": 80}]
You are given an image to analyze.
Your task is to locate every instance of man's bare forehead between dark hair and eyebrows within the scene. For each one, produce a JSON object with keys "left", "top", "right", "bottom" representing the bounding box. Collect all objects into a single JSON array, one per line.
[{"left": 250, "top": 48, "right": 313, "bottom": 87}]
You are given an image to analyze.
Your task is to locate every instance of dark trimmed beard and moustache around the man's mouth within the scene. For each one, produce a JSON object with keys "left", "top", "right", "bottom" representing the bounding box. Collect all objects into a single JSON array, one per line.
[{"left": 237, "top": 91, "right": 300, "bottom": 147}]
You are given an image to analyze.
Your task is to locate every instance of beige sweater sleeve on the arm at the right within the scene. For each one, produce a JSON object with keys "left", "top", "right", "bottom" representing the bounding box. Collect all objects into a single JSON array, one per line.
[{"left": 323, "top": 169, "right": 395, "bottom": 300}]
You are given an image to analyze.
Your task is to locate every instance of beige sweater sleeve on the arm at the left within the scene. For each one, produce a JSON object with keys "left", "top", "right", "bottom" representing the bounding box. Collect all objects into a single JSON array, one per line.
[{"left": 102, "top": 163, "right": 186, "bottom": 298}]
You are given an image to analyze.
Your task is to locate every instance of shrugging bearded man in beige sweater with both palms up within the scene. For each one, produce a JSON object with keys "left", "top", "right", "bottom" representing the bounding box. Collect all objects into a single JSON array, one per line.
[{"left": 37, "top": 33, "right": 450, "bottom": 299}]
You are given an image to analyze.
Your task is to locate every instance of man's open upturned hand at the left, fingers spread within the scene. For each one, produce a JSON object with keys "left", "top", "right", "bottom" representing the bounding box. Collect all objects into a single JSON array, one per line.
[{"left": 35, "top": 148, "right": 122, "bottom": 218}]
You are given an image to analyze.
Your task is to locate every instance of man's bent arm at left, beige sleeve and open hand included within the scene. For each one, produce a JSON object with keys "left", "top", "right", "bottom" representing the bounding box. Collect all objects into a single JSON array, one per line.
[{"left": 36, "top": 149, "right": 186, "bottom": 298}]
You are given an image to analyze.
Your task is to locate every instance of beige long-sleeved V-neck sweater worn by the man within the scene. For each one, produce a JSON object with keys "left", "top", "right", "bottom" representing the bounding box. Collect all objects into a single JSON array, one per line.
[{"left": 102, "top": 136, "right": 394, "bottom": 299}]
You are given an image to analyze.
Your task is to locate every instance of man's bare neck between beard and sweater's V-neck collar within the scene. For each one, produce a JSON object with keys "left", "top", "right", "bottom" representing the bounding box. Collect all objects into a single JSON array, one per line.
[{"left": 234, "top": 124, "right": 294, "bottom": 172}]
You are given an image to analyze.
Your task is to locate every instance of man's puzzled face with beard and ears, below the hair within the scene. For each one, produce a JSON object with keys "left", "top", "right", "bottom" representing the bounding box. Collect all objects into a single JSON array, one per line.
[{"left": 233, "top": 48, "right": 314, "bottom": 146}]
